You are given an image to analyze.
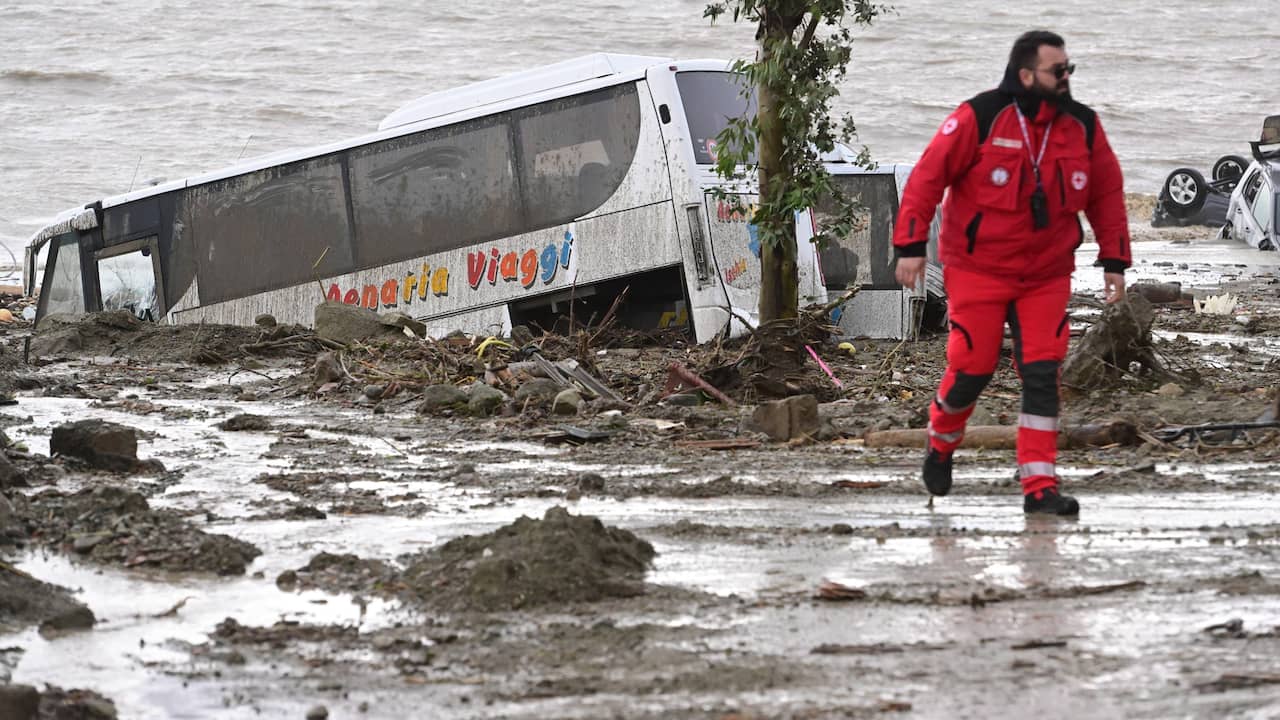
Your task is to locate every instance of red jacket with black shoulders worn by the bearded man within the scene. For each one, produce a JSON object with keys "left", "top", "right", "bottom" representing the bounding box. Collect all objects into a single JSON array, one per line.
[{"left": 893, "top": 86, "right": 1130, "bottom": 282}]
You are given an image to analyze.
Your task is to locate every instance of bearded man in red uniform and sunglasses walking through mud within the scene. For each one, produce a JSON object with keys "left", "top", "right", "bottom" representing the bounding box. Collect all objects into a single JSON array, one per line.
[{"left": 893, "top": 31, "right": 1130, "bottom": 515}]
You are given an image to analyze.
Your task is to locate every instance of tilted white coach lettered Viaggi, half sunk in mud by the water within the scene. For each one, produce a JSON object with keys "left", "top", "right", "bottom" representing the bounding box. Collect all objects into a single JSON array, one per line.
[{"left": 26, "top": 54, "right": 936, "bottom": 342}]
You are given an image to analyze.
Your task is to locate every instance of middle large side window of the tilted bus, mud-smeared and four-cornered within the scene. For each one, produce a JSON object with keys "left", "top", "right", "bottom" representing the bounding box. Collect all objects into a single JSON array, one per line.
[{"left": 351, "top": 117, "right": 522, "bottom": 268}]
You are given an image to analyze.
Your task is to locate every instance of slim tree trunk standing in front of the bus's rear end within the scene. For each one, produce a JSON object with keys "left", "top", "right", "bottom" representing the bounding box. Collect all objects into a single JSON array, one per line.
[{"left": 755, "top": 17, "right": 800, "bottom": 324}]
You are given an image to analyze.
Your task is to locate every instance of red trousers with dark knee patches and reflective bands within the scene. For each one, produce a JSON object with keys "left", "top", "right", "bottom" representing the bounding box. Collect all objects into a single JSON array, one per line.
[{"left": 929, "top": 268, "right": 1071, "bottom": 495}]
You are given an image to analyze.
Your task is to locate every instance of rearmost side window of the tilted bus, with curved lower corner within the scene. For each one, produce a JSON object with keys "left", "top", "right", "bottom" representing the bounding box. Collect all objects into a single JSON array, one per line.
[{"left": 517, "top": 85, "right": 640, "bottom": 229}]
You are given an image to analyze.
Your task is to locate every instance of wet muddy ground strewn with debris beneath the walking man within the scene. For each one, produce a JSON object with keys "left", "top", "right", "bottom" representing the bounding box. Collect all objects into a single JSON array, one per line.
[{"left": 0, "top": 208, "right": 1280, "bottom": 719}]
